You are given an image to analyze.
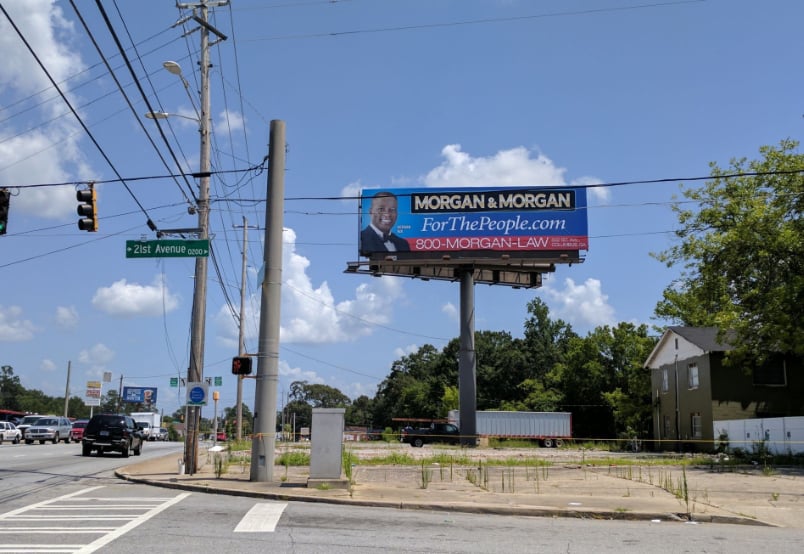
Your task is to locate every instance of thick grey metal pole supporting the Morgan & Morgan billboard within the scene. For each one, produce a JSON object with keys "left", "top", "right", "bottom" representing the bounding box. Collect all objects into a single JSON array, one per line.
[{"left": 458, "top": 268, "right": 477, "bottom": 446}]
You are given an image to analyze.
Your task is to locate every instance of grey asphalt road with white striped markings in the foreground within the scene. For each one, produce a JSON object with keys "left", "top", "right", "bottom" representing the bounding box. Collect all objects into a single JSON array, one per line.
[{"left": 0, "top": 443, "right": 804, "bottom": 554}]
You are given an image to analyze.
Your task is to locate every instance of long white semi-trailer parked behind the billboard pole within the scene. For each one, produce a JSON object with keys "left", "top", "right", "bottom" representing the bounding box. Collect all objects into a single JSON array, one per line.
[{"left": 449, "top": 410, "right": 572, "bottom": 447}]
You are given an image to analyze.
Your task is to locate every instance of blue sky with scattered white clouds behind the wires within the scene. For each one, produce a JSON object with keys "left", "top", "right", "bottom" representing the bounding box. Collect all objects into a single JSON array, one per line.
[{"left": 0, "top": 0, "right": 804, "bottom": 415}]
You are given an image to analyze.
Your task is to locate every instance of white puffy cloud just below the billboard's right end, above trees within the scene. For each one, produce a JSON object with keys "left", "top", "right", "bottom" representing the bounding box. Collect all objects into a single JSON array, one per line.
[{"left": 542, "top": 278, "right": 616, "bottom": 329}]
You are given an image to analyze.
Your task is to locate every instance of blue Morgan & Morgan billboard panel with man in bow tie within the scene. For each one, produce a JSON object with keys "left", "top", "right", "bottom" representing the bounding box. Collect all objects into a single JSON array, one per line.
[{"left": 359, "top": 187, "right": 589, "bottom": 256}]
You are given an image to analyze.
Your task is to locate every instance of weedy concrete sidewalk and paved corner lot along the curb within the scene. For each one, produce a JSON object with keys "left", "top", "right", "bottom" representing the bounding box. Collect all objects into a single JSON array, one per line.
[{"left": 117, "top": 451, "right": 804, "bottom": 529}]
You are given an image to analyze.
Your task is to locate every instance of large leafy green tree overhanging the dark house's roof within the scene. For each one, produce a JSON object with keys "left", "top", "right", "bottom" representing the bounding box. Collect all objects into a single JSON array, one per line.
[{"left": 654, "top": 140, "right": 804, "bottom": 363}]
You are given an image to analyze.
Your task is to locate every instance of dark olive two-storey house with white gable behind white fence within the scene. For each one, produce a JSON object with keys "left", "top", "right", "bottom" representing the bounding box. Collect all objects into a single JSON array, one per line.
[{"left": 645, "top": 327, "right": 804, "bottom": 451}]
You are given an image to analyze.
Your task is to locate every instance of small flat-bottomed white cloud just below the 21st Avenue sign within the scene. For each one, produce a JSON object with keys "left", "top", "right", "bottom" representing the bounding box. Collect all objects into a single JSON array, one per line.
[{"left": 92, "top": 275, "right": 179, "bottom": 317}]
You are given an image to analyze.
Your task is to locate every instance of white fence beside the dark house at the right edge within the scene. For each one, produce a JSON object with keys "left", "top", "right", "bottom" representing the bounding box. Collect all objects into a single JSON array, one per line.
[{"left": 714, "top": 416, "right": 804, "bottom": 454}]
